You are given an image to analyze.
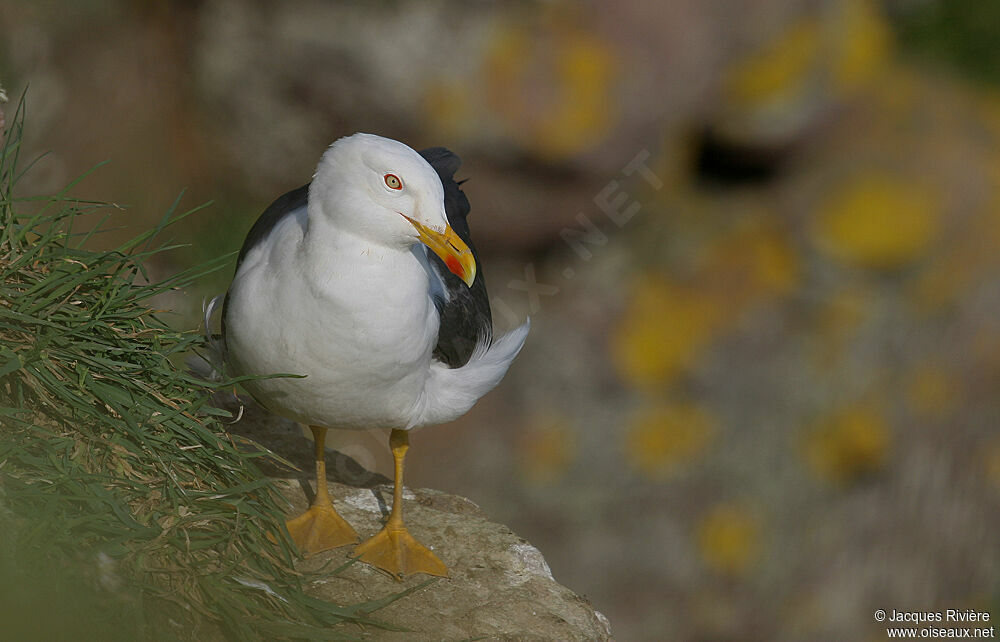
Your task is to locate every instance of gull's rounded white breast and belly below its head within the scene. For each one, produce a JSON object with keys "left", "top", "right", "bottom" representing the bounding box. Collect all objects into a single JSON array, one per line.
[{"left": 225, "top": 208, "right": 446, "bottom": 429}]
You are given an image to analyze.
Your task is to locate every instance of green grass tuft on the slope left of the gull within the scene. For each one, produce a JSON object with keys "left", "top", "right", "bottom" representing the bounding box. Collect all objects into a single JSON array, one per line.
[{"left": 0, "top": 92, "right": 403, "bottom": 640}]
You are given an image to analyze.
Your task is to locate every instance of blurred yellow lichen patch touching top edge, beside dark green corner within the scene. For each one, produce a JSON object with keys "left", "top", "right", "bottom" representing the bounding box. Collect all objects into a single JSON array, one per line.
[{"left": 833, "top": 0, "right": 891, "bottom": 92}]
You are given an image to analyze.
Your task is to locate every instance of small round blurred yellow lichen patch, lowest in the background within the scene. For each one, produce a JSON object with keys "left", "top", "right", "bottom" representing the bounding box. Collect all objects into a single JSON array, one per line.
[{"left": 696, "top": 503, "right": 761, "bottom": 575}]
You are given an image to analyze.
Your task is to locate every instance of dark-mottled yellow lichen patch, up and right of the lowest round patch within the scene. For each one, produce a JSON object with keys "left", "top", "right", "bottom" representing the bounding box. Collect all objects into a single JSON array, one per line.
[{"left": 805, "top": 405, "right": 889, "bottom": 484}]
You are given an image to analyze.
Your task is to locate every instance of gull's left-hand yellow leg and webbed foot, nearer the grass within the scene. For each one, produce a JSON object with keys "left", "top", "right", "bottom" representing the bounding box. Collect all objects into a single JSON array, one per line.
[{"left": 285, "top": 426, "right": 358, "bottom": 554}]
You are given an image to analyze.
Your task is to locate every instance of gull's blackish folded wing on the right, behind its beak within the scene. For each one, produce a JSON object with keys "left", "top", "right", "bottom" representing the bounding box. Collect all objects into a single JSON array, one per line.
[{"left": 420, "top": 147, "right": 493, "bottom": 368}]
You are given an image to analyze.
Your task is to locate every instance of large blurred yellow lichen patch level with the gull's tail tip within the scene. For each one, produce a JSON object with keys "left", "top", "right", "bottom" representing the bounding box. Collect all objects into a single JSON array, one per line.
[{"left": 611, "top": 277, "right": 724, "bottom": 386}]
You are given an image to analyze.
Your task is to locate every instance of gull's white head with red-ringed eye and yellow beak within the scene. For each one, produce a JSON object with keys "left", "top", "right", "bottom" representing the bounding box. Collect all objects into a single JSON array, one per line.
[{"left": 309, "top": 133, "right": 476, "bottom": 287}]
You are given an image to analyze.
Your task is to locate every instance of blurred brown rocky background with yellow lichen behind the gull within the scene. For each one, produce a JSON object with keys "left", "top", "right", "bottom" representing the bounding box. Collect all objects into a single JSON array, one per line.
[{"left": 0, "top": 0, "right": 1000, "bottom": 640}]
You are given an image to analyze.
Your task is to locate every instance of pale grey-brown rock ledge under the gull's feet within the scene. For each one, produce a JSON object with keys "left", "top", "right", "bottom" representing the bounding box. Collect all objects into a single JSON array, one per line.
[{"left": 277, "top": 478, "right": 612, "bottom": 640}]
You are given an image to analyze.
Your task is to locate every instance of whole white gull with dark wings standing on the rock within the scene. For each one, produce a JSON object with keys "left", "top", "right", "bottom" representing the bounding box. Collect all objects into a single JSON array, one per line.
[{"left": 222, "top": 133, "right": 530, "bottom": 579}]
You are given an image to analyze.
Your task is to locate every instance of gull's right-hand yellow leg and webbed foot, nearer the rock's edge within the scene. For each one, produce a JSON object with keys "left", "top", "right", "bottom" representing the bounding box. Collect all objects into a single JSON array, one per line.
[{"left": 354, "top": 430, "right": 448, "bottom": 579}]
